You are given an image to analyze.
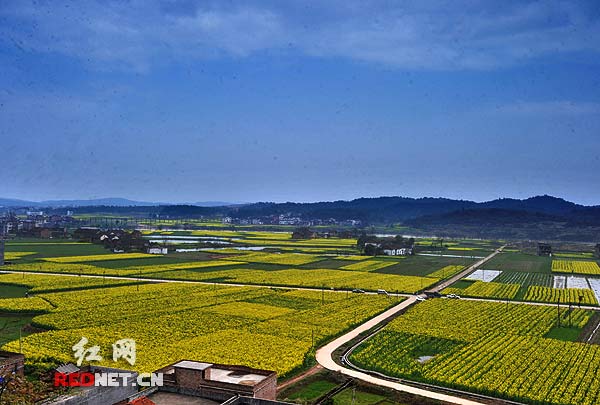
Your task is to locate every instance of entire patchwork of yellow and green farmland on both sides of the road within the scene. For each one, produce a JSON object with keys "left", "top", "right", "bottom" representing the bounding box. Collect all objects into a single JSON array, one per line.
[{"left": 0, "top": 229, "right": 600, "bottom": 404}]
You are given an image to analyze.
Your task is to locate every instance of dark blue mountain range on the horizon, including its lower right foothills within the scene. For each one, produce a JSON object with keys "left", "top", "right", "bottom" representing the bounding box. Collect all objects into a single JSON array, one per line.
[{"left": 0, "top": 195, "right": 600, "bottom": 243}]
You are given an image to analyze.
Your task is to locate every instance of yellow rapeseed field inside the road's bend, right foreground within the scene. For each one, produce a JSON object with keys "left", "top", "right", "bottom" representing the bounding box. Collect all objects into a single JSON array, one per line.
[{"left": 351, "top": 300, "right": 600, "bottom": 404}]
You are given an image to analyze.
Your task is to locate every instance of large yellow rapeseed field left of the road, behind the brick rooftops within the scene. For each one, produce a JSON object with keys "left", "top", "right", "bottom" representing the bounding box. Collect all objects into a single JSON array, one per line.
[{"left": 0, "top": 275, "right": 397, "bottom": 376}]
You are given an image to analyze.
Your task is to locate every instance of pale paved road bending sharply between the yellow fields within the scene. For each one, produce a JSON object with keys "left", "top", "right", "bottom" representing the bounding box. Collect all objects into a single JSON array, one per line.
[{"left": 316, "top": 248, "right": 502, "bottom": 405}]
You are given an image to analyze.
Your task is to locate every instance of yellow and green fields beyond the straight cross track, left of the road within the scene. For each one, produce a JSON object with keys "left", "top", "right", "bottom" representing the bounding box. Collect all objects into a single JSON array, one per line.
[{"left": 0, "top": 234, "right": 480, "bottom": 293}]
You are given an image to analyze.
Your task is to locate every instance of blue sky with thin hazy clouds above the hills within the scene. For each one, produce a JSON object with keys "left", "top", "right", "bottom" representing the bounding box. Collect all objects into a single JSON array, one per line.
[{"left": 0, "top": 0, "right": 600, "bottom": 205}]
